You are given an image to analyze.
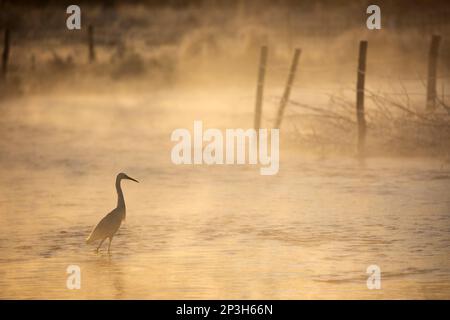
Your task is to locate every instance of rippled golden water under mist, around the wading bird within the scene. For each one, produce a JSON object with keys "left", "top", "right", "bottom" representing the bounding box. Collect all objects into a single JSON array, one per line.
[{"left": 0, "top": 90, "right": 450, "bottom": 299}]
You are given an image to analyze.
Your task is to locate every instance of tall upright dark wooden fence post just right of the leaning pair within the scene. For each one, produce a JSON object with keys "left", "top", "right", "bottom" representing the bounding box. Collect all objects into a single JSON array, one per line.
[{"left": 356, "top": 41, "right": 367, "bottom": 157}]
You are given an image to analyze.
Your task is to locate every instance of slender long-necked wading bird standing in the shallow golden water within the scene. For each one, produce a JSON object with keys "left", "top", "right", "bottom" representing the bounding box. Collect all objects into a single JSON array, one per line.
[{"left": 86, "top": 173, "right": 139, "bottom": 252}]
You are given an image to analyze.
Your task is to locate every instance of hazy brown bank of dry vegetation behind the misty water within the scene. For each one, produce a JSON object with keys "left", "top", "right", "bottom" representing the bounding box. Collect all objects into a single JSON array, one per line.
[{"left": 0, "top": 1, "right": 450, "bottom": 159}]
